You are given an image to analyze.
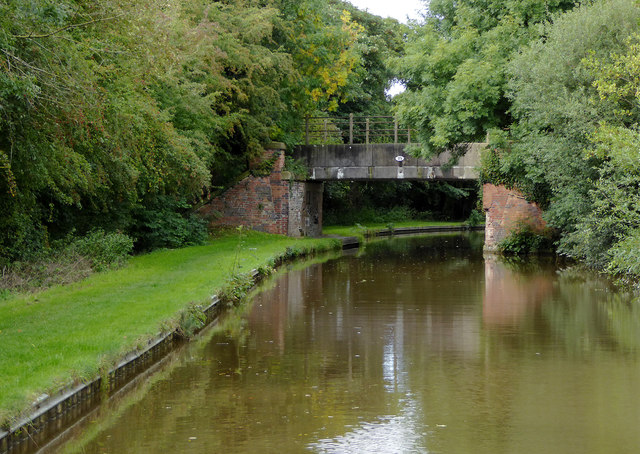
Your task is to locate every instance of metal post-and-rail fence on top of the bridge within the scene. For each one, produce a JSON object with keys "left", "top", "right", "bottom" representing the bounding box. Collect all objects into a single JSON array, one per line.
[{"left": 304, "top": 114, "right": 415, "bottom": 145}]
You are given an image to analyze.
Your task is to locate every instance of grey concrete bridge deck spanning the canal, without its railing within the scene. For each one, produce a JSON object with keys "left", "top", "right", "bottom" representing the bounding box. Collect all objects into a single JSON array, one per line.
[{"left": 293, "top": 143, "right": 486, "bottom": 181}]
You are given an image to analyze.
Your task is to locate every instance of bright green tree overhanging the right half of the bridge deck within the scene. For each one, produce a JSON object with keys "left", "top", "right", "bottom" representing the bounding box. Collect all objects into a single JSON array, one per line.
[{"left": 394, "top": 0, "right": 576, "bottom": 155}]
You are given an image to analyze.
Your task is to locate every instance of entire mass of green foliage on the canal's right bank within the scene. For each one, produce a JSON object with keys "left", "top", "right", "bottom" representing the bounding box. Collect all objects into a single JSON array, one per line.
[{"left": 395, "top": 0, "right": 640, "bottom": 276}]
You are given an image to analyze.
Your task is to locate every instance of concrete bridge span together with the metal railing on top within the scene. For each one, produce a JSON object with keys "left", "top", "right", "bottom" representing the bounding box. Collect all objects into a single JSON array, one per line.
[{"left": 293, "top": 116, "right": 486, "bottom": 181}]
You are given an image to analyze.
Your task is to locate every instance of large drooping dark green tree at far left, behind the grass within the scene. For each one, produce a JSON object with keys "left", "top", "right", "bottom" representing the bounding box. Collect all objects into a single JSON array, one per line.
[{"left": 0, "top": 0, "right": 215, "bottom": 258}]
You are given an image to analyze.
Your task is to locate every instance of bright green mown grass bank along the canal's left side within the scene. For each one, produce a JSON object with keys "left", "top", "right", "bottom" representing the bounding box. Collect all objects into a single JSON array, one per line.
[{"left": 0, "top": 231, "right": 337, "bottom": 424}]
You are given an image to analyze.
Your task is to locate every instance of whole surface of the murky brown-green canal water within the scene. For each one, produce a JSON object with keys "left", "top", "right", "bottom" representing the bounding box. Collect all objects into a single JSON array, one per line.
[{"left": 55, "top": 233, "right": 640, "bottom": 454}]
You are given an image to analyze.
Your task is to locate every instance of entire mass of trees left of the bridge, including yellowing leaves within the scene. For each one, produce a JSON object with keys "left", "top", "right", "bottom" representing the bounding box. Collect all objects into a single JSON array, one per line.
[{"left": 0, "top": 0, "right": 397, "bottom": 263}]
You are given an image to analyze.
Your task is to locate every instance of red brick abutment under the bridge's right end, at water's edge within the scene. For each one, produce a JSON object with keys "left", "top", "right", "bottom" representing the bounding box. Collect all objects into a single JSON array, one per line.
[{"left": 482, "top": 184, "right": 545, "bottom": 251}]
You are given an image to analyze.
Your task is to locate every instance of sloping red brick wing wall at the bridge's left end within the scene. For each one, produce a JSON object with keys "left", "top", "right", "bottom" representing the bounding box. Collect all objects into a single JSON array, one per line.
[{"left": 200, "top": 149, "right": 289, "bottom": 235}]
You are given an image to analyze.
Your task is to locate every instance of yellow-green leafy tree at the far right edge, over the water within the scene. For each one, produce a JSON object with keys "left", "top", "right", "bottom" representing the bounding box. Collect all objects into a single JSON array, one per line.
[{"left": 569, "top": 33, "right": 640, "bottom": 277}]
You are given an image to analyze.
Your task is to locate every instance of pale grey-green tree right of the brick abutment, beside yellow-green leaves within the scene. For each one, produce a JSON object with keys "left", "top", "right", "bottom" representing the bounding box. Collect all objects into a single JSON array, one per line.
[{"left": 500, "top": 0, "right": 640, "bottom": 263}]
